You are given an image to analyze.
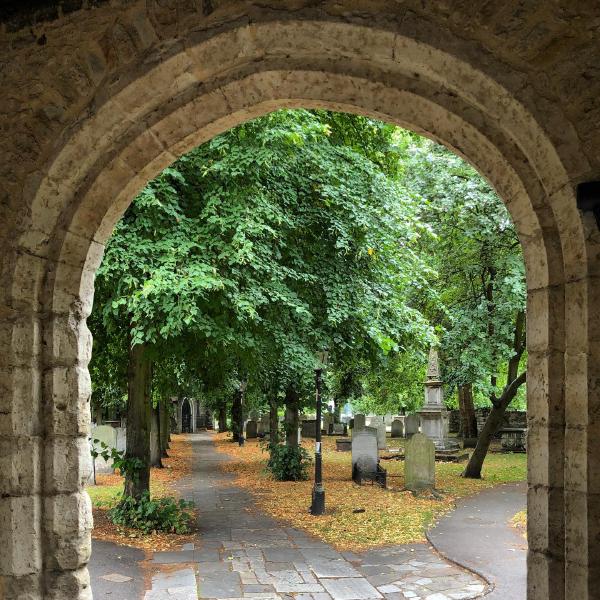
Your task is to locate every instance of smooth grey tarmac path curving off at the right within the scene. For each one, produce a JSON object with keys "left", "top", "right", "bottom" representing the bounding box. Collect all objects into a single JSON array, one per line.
[{"left": 427, "top": 482, "right": 527, "bottom": 600}]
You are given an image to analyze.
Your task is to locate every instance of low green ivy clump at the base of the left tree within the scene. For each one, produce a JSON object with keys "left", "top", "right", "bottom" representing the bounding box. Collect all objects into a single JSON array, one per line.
[{"left": 108, "top": 493, "right": 194, "bottom": 534}]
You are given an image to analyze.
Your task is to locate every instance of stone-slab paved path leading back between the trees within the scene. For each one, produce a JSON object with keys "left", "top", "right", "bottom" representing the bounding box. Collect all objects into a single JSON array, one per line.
[{"left": 143, "top": 433, "right": 487, "bottom": 600}]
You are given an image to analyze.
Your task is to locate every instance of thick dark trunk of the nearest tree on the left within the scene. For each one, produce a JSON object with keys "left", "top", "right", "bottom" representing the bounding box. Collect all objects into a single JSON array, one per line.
[{"left": 125, "top": 344, "right": 152, "bottom": 498}]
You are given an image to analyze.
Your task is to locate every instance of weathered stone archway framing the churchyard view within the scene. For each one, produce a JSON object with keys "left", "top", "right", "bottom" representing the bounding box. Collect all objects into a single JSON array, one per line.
[{"left": 0, "top": 2, "right": 600, "bottom": 600}]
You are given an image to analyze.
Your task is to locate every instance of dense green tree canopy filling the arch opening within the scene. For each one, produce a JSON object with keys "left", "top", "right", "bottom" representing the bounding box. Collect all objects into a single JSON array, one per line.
[{"left": 90, "top": 110, "right": 526, "bottom": 432}]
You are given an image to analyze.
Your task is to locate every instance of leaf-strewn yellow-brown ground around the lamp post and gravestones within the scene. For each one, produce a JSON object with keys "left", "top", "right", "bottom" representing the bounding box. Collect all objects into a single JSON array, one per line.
[{"left": 215, "top": 434, "right": 527, "bottom": 550}]
